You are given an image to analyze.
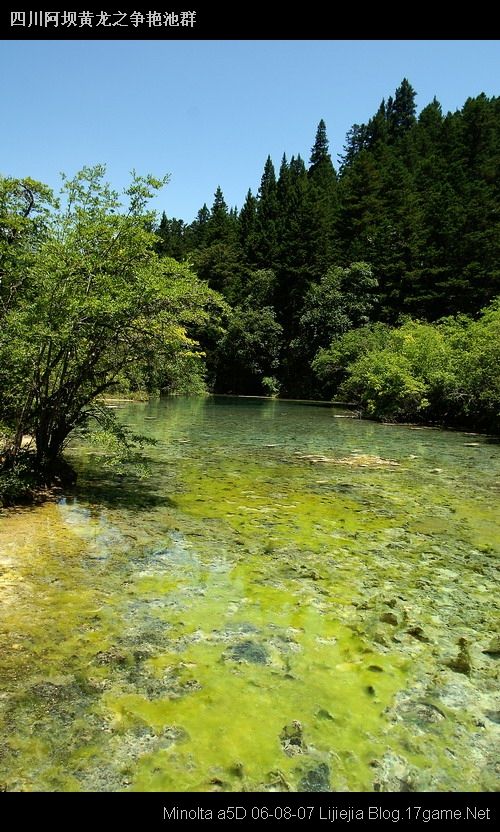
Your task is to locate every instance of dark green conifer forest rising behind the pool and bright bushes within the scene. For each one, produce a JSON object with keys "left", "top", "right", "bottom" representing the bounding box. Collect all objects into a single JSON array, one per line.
[{"left": 157, "top": 79, "right": 500, "bottom": 422}]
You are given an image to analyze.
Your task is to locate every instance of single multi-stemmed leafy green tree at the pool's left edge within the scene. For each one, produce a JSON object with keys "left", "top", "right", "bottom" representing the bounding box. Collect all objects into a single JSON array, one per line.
[{"left": 0, "top": 166, "right": 219, "bottom": 479}]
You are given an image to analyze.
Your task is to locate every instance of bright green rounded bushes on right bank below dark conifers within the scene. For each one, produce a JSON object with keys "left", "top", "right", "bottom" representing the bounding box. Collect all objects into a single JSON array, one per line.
[{"left": 313, "top": 300, "right": 500, "bottom": 432}]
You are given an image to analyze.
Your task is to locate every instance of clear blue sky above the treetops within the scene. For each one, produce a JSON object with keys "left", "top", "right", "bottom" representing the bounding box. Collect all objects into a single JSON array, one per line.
[{"left": 0, "top": 40, "right": 500, "bottom": 221}]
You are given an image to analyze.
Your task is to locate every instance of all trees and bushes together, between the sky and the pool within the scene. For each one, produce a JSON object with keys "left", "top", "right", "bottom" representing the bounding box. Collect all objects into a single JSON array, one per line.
[{"left": 0, "top": 80, "right": 500, "bottom": 499}]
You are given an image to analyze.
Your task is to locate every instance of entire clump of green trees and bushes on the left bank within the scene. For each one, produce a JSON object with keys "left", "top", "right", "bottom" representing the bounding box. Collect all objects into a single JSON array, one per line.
[{"left": 0, "top": 166, "right": 220, "bottom": 500}]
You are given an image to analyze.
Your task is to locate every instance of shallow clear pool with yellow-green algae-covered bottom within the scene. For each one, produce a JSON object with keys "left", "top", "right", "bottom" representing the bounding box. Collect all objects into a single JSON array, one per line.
[{"left": 0, "top": 398, "right": 500, "bottom": 791}]
